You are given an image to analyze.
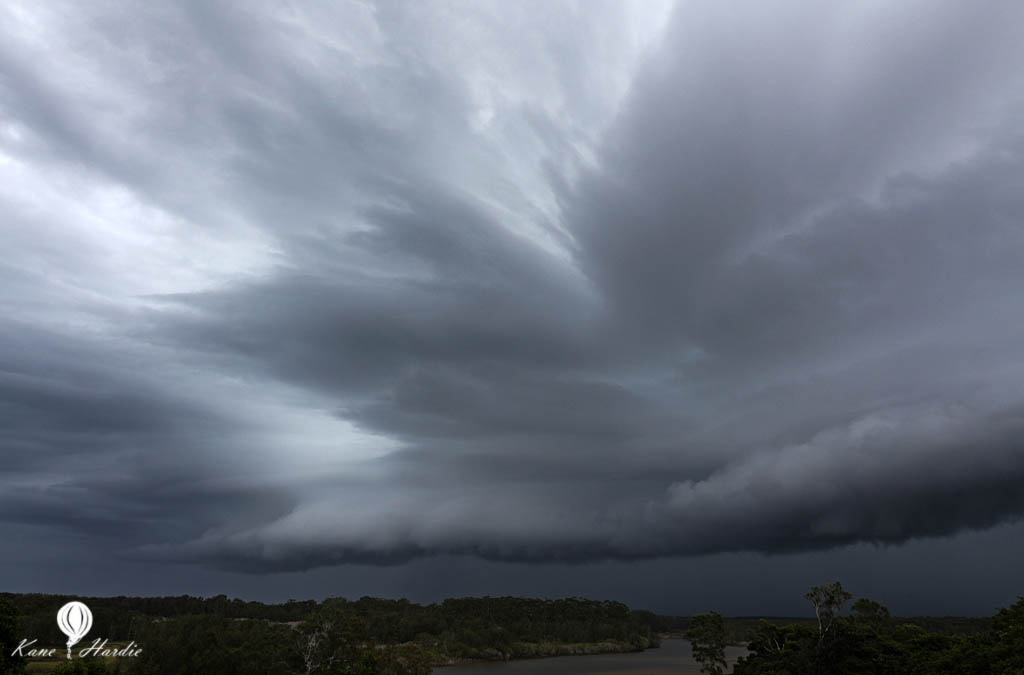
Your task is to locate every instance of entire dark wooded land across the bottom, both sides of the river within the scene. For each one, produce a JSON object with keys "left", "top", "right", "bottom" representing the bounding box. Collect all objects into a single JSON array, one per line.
[{"left": 0, "top": 584, "right": 1024, "bottom": 675}]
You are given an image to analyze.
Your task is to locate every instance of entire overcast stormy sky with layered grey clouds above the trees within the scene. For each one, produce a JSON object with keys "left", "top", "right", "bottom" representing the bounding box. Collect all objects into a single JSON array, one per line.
[{"left": 0, "top": 0, "right": 1024, "bottom": 614}]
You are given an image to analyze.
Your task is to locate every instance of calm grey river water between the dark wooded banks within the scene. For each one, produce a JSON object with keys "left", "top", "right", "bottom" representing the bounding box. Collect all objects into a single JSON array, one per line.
[{"left": 434, "top": 639, "right": 746, "bottom": 675}]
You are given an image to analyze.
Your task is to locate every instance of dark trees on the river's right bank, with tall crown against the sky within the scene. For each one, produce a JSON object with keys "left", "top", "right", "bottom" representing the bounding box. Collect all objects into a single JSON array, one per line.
[{"left": 687, "top": 582, "right": 1024, "bottom": 675}]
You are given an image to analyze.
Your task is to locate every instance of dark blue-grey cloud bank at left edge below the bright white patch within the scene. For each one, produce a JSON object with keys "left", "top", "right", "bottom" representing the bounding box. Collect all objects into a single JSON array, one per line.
[{"left": 0, "top": 324, "right": 293, "bottom": 549}]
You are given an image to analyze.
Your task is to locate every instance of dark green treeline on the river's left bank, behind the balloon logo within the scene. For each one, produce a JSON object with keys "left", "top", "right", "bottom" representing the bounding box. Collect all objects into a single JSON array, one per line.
[{"left": 0, "top": 593, "right": 665, "bottom": 675}]
